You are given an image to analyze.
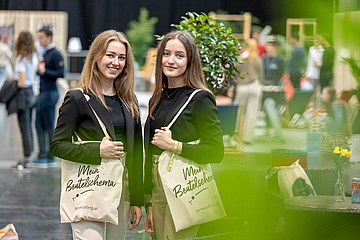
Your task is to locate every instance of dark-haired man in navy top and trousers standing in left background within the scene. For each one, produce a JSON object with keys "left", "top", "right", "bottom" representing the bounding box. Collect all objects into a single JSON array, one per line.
[{"left": 32, "top": 28, "right": 64, "bottom": 168}]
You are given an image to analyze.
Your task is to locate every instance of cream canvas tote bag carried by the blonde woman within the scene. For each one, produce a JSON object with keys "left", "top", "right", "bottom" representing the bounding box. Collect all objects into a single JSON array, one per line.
[{"left": 60, "top": 90, "right": 125, "bottom": 225}]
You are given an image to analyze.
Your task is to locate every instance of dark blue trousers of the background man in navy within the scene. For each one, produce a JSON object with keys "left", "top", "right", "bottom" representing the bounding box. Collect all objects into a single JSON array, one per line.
[{"left": 35, "top": 90, "right": 59, "bottom": 159}]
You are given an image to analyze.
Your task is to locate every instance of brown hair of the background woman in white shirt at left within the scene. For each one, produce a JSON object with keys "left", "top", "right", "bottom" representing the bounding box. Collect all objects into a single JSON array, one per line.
[{"left": 15, "top": 31, "right": 36, "bottom": 59}]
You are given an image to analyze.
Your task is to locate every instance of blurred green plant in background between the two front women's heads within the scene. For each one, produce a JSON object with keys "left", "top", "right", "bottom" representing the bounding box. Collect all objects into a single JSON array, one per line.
[{"left": 125, "top": 8, "right": 158, "bottom": 66}]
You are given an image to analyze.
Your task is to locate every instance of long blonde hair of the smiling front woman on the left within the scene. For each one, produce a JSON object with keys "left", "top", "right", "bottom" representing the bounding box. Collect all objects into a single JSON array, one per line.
[{"left": 78, "top": 30, "right": 140, "bottom": 119}]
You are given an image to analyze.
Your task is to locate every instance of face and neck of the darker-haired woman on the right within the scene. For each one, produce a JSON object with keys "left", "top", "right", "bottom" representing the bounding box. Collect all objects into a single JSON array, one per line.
[{"left": 162, "top": 39, "right": 188, "bottom": 88}]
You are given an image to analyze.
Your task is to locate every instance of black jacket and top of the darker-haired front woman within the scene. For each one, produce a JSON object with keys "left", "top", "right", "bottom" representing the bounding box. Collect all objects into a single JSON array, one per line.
[{"left": 144, "top": 87, "right": 224, "bottom": 194}]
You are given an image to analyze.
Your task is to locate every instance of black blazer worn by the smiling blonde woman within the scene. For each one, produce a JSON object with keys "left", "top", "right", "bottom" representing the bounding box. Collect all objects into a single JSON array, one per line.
[{"left": 50, "top": 90, "right": 143, "bottom": 206}]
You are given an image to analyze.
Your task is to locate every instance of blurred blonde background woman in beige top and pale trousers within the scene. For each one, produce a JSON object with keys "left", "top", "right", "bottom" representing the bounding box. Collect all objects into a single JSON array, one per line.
[{"left": 235, "top": 39, "right": 264, "bottom": 144}]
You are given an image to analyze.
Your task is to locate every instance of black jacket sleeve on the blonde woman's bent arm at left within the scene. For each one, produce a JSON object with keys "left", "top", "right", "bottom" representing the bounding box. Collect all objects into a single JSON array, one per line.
[{"left": 50, "top": 90, "right": 101, "bottom": 164}]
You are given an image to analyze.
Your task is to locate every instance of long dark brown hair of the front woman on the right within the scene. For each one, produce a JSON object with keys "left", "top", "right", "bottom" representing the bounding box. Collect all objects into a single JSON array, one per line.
[{"left": 149, "top": 31, "right": 210, "bottom": 119}]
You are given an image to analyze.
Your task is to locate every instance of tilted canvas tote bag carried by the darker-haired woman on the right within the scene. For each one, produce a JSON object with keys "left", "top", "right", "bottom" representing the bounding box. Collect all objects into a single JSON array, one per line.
[{"left": 158, "top": 90, "right": 226, "bottom": 232}]
